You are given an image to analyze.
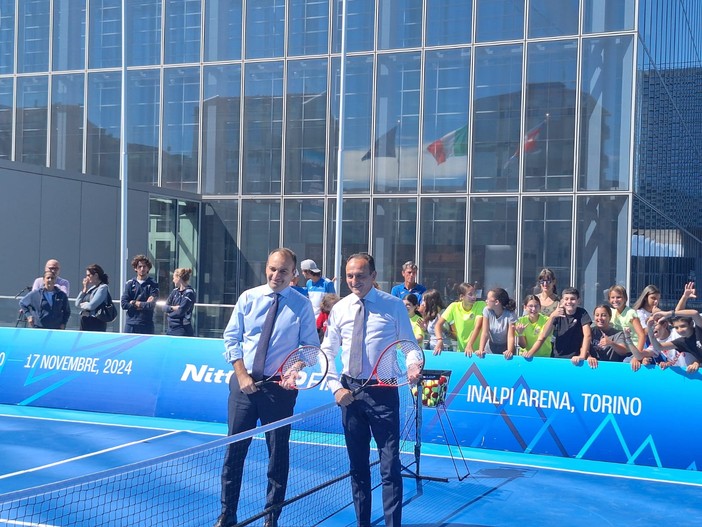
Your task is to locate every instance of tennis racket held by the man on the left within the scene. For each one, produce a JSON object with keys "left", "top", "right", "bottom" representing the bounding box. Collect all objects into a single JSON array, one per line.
[{"left": 255, "top": 346, "right": 329, "bottom": 390}]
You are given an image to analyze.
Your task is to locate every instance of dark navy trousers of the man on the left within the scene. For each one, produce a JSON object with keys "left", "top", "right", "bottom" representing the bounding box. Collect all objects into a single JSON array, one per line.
[{"left": 222, "top": 374, "right": 297, "bottom": 523}]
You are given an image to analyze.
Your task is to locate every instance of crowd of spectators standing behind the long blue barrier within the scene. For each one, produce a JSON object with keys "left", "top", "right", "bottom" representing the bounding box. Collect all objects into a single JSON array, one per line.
[{"left": 6, "top": 255, "right": 702, "bottom": 372}]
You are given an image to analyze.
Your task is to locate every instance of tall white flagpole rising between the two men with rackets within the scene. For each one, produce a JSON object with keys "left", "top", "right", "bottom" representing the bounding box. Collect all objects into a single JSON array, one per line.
[{"left": 332, "top": 0, "right": 346, "bottom": 284}]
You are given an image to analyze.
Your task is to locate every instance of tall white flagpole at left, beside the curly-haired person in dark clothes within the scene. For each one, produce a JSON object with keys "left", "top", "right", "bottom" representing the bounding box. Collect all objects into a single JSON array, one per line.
[{"left": 118, "top": 0, "right": 129, "bottom": 332}]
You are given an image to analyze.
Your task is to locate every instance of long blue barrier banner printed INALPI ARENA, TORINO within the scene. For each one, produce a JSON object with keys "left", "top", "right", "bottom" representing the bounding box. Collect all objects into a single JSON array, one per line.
[{"left": 0, "top": 328, "right": 702, "bottom": 470}]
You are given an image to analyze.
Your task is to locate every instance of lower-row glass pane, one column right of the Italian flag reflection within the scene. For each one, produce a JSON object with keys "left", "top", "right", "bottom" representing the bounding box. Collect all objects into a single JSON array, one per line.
[{"left": 466, "top": 197, "right": 519, "bottom": 297}]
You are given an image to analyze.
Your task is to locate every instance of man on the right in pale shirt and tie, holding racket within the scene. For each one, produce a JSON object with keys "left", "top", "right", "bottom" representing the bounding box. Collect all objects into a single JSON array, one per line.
[{"left": 322, "top": 253, "right": 415, "bottom": 527}]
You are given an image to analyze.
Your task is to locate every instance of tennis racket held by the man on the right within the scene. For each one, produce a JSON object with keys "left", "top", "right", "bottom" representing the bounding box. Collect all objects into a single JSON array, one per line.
[{"left": 353, "top": 340, "right": 424, "bottom": 395}]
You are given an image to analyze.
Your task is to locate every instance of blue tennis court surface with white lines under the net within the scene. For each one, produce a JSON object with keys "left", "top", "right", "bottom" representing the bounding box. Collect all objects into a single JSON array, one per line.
[{"left": 0, "top": 406, "right": 702, "bottom": 527}]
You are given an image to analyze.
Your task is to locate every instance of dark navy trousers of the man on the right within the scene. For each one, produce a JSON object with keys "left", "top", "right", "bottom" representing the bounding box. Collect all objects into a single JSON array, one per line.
[{"left": 341, "top": 376, "right": 402, "bottom": 527}]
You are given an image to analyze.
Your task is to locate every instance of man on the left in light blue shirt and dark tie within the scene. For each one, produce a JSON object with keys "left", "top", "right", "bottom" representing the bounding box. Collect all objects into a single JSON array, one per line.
[{"left": 215, "top": 248, "right": 319, "bottom": 527}]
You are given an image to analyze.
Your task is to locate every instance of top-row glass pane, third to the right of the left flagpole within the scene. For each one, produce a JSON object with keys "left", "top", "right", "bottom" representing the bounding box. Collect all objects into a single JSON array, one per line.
[{"left": 204, "top": 0, "right": 242, "bottom": 62}]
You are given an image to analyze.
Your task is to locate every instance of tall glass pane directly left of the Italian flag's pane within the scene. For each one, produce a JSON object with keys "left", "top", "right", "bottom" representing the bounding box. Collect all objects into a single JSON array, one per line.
[{"left": 376, "top": 53, "right": 420, "bottom": 192}]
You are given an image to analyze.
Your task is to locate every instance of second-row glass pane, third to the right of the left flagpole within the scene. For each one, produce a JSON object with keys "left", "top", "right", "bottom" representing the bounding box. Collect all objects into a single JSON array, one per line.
[{"left": 202, "top": 64, "right": 241, "bottom": 194}]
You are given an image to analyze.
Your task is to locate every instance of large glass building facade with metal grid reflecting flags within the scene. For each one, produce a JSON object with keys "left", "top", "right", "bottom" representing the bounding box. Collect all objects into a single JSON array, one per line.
[{"left": 0, "top": 0, "right": 702, "bottom": 334}]
